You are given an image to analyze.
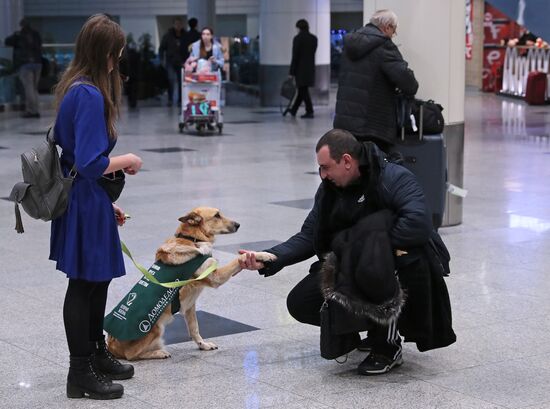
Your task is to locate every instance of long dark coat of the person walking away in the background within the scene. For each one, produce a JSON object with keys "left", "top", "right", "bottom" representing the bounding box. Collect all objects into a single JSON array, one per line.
[{"left": 289, "top": 30, "right": 317, "bottom": 87}]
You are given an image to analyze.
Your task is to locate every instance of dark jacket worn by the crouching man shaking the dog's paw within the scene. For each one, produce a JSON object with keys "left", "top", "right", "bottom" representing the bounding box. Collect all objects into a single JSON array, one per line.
[{"left": 260, "top": 143, "right": 455, "bottom": 350}]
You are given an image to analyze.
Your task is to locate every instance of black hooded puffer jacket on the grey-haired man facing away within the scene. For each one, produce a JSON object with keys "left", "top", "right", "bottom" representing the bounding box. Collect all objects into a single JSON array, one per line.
[{"left": 334, "top": 24, "right": 418, "bottom": 144}]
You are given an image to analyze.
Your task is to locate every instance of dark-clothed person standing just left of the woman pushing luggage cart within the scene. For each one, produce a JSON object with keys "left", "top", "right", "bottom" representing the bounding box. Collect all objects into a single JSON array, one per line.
[{"left": 159, "top": 17, "right": 188, "bottom": 107}]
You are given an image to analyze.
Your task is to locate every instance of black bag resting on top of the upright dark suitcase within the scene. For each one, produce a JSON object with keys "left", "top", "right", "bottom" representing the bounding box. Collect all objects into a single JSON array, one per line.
[{"left": 397, "top": 95, "right": 445, "bottom": 135}]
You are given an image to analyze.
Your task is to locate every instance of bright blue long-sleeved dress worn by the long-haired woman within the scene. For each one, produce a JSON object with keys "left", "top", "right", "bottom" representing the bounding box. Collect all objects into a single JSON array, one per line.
[{"left": 50, "top": 84, "right": 126, "bottom": 281}]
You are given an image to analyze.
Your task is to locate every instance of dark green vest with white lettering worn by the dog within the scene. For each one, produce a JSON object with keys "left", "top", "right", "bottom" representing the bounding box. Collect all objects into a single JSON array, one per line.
[{"left": 103, "top": 255, "right": 210, "bottom": 341}]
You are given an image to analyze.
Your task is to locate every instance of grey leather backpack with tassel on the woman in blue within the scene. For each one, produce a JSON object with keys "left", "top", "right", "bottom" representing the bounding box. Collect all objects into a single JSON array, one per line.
[{"left": 9, "top": 127, "right": 76, "bottom": 233}]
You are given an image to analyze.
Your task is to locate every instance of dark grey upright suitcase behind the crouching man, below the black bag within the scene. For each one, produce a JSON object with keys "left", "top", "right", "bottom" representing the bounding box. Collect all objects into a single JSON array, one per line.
[{"left": 391, "top": 106, "right": 447, "bottom": 230}]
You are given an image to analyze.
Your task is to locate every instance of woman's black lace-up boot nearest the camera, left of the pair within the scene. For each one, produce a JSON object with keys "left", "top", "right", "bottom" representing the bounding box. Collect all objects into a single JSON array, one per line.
[{"left": 67, "top": 356, "right": 124, "bottom": 399}]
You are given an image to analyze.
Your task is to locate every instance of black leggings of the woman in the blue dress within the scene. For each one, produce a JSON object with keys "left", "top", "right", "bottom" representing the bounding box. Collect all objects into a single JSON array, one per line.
[{"left": 63, "top": 279, "right": 111, "bottom": 357}]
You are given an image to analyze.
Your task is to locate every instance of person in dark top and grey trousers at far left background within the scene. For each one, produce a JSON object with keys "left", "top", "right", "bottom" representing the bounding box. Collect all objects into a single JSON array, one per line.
[{"left": 4, "top": 18, "right": 42, "bottom": 118}]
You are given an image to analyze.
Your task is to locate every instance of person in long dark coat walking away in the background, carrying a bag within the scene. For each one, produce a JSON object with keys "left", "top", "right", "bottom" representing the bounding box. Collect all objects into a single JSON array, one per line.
[{"left": 283, "top": 19, "right": 317, "bottom": 118}]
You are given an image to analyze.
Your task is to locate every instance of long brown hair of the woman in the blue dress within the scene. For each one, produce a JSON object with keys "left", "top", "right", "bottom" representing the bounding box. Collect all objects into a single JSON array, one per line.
[{"left": 55, "top": 14, "right": 126, "bottom": 139}]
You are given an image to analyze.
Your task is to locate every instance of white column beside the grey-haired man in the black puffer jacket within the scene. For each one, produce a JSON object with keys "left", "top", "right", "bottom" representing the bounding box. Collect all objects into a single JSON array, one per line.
[{"left": 363, "top": 0, "right": 466, "bottom": 225}]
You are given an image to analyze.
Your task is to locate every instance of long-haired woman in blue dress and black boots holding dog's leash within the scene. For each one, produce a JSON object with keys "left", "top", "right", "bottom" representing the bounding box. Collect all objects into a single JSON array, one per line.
[{"left": 50, "top": 14, "right": 141, "bottom": 399}]
